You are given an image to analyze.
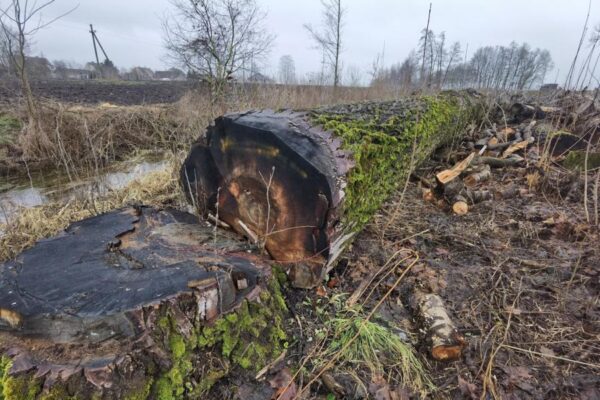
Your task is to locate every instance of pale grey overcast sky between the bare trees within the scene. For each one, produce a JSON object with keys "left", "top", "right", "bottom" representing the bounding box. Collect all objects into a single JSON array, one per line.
[{"left": 19, "top": 0, "right": 600, "bottom": 82}]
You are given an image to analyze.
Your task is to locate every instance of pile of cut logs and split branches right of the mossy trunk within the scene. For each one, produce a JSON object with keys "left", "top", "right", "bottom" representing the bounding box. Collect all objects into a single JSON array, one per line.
[{"left": 423, "top": 120, "right": 536, "bottom": 215}]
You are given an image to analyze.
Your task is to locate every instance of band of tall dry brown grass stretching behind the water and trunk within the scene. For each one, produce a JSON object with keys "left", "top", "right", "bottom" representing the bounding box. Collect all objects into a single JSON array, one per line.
[{"left": 0, "top": 85, "right": 400, "bottom": 179}]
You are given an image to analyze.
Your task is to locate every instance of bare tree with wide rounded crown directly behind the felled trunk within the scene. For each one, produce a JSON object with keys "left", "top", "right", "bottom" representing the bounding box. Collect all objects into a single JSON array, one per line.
[{"left": 163, "top": 0, "right": 273, "bottom": 100}]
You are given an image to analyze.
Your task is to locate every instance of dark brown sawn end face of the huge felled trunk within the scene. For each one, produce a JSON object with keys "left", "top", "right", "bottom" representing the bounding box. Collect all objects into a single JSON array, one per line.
[{"left": 181, "top": 111, "right": 340, "bottom": 287}]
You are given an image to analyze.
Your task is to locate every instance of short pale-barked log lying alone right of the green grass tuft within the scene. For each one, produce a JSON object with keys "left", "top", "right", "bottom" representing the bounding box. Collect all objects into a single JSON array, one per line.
[{"left": 411, "top": 289, "right": 466, "bottom": 361}]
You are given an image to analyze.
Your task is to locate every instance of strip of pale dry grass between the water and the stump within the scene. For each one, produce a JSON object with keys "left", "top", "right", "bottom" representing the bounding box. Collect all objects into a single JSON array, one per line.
[{"left": 0, "top": 152, "right": 184, "bottom": 261}]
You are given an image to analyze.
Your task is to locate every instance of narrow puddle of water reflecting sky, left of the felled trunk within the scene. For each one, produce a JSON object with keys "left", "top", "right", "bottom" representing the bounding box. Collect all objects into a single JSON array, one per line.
[{"left": 0, "top": 160, "right": 168, "bottom": 225}]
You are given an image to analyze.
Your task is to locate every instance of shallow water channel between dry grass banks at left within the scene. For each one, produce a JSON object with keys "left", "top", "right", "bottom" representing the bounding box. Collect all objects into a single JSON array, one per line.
[{"left": 0, "top": 156, "right": 168, "bottom": 223}]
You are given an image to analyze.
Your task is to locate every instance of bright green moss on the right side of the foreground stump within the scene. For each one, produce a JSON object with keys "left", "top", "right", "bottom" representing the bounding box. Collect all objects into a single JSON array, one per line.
[{"left": 152, "top": 277, "right": 287, "bottom": 400}]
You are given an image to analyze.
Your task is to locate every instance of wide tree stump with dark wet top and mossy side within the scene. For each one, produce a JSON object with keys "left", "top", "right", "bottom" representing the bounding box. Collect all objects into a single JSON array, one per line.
[{"left": 0, "top": 207, "right": 286, "bottom": 400}]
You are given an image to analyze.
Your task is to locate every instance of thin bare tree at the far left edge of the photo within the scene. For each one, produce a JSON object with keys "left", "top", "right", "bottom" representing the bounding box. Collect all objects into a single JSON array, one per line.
[{"left": 0, "top": 0, "right": 75, "bottom": 130}]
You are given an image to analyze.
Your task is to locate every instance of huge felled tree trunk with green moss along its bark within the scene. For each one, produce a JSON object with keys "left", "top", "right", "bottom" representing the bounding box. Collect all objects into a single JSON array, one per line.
[{"left": 181, "top": 93, "right": 479, "bottom": 288}]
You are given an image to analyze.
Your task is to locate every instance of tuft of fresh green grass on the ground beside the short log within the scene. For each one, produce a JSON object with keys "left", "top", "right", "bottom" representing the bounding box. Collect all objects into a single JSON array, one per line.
[{"left": 325, "top": 310, "right": 435, "bottom": 396}]
